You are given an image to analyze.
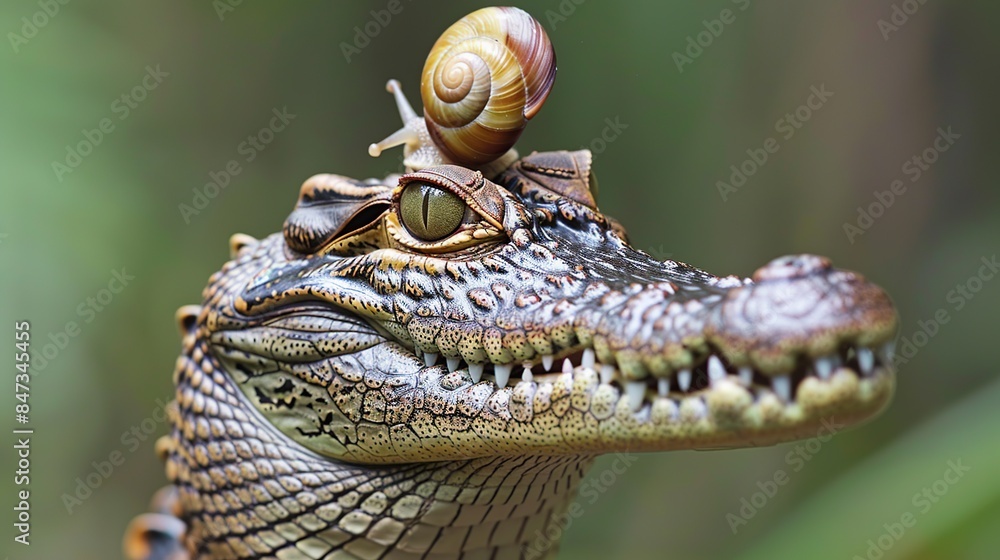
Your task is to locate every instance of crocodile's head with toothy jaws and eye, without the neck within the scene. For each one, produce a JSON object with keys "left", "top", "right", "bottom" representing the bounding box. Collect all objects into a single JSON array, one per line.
[{"left": 199, "top": 151, "right": 896, "bottom": 464}]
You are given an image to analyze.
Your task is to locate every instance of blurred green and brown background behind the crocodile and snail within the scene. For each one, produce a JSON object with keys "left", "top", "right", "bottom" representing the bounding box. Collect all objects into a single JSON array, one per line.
[{"left": 0, "top": 0, "right": 1000, "bottom": 559}]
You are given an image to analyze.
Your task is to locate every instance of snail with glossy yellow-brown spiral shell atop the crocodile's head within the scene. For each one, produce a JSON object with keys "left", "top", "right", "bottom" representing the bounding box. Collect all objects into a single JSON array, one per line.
[{"left": 368, "top": 7, "right": 556, "bottom": 176}]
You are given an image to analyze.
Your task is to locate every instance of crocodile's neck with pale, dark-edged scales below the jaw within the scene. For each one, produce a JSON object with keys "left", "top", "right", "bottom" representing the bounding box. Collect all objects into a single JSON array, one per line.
[{"left": 167, "top": 337, "right": 594, "bottom": 560}]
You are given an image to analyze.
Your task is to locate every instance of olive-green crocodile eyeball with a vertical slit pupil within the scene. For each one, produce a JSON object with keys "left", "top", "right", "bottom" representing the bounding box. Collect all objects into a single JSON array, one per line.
[{"left": 399, "top": 182, "right": 466, "bottom": 241}]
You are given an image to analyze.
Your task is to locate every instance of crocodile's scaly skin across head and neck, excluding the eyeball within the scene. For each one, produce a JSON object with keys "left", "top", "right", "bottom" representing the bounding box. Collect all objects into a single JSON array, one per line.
[{"left": 125, "top": 151, "right": 896, "bottom": 560}]
